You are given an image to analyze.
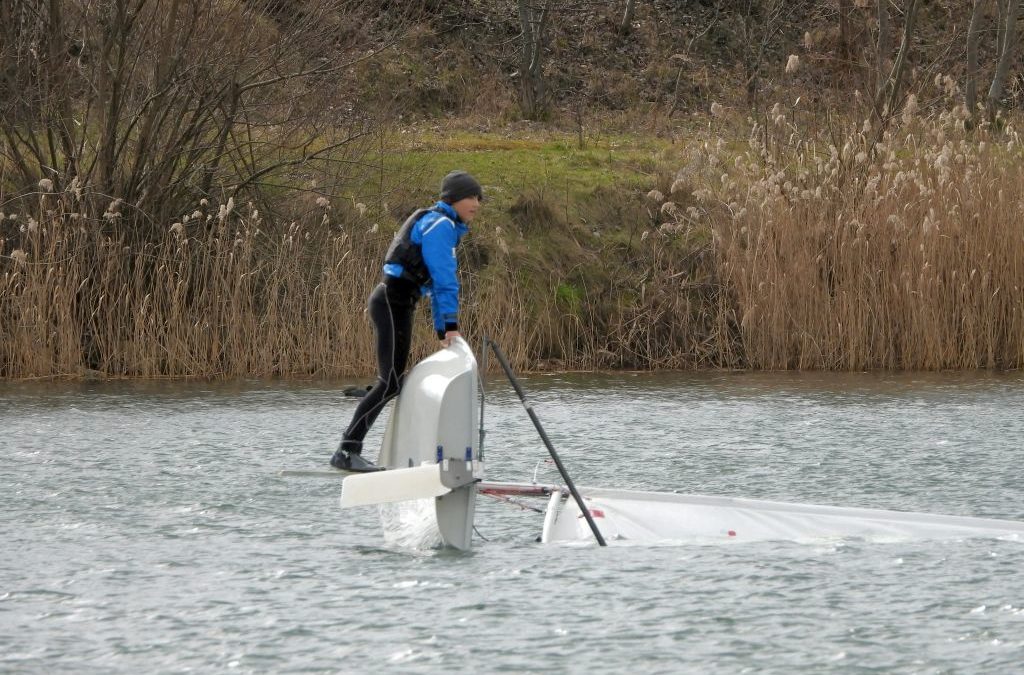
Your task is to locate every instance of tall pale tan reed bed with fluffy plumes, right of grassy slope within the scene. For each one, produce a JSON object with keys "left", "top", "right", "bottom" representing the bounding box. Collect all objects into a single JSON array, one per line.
[{"left": 697, "top": 100, "right": 1024, "bottom": 370}]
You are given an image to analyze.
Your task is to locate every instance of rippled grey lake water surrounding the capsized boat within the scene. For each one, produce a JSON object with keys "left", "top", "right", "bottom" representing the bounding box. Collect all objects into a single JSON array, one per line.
[{"left": 0, "top": 373, "right": 1024, "bottom": 673}]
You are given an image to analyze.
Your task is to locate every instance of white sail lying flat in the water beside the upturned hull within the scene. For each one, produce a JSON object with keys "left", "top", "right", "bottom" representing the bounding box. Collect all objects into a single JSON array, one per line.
[{"left": 541, "top": 488, "right": 1024, "bottom": 544}]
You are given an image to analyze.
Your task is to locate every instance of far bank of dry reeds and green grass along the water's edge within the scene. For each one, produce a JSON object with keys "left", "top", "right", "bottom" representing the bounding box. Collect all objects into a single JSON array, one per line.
[{"left": 0, "top": 111, "right": 1024, "bottom": 378}]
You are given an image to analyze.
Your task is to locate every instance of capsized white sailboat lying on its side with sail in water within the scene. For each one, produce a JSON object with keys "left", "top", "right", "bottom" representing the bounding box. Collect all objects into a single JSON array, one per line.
[{"left": 341, "top": 338, "right": 1024, "bottom": 550}]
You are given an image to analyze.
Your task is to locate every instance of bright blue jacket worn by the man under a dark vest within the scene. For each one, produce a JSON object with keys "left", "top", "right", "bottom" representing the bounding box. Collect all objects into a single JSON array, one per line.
[{"left": 384, "top": 202, "right": 469, "bottom": 335}]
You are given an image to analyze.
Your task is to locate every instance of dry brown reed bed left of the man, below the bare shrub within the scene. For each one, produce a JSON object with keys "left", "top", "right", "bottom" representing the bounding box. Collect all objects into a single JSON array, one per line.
[{"left": 0, "top": 194, "right": 382, "bottom": 378}]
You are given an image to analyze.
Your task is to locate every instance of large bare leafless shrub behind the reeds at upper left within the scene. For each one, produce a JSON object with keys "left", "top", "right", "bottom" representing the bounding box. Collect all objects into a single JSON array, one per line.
[{"left": 0, "top": 0, "right": 412, "bottom": 235}]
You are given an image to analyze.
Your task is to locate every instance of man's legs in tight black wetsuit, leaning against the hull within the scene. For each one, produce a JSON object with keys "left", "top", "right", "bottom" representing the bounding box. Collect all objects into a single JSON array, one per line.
[{"left": 341, "top": 280, "right": 419, "bottom": 452}]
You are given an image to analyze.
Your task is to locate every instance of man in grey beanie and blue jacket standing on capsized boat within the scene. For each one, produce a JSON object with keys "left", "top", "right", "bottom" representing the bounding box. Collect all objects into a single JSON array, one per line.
[{"left": 331, "top": 171, "right": 483, "bottom": 472}]
